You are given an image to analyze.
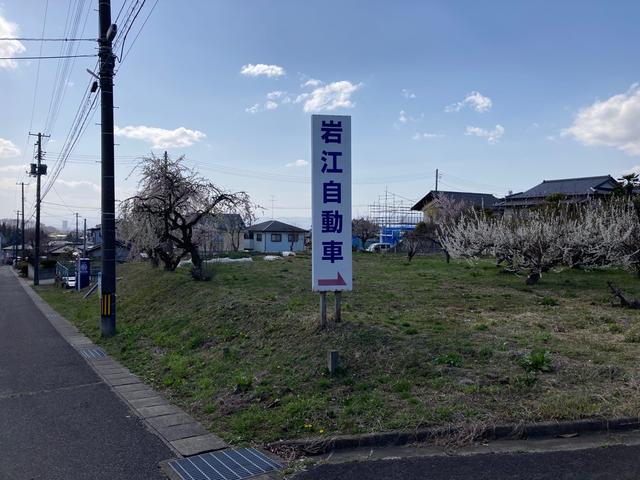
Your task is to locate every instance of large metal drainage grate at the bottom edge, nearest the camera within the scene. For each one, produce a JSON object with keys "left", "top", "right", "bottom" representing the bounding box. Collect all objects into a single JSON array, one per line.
[{"left": 169, "top": 448, "right": 282, "bottom": 480}]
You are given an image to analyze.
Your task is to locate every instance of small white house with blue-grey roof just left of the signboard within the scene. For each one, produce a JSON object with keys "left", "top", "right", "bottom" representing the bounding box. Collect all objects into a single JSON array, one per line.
[{"left": 244, "top": 220, "right": 307, "bottom": 252}]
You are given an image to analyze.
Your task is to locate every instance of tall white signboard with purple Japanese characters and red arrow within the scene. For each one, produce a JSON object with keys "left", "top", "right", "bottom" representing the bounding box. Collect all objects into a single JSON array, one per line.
[{"left": 311, "top": 115, "right": 353, "bottom": 292}]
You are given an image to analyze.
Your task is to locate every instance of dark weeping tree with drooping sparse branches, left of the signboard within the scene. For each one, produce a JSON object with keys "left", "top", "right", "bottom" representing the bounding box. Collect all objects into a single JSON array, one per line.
[{"left": 121, "top": 152, "right": 248, "bottom": 280}]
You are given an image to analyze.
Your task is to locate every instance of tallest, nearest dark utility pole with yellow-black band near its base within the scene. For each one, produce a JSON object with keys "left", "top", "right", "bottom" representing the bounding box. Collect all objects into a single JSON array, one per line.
[{"left": 98, "top": 0, "right": 117, "bottom": 337}]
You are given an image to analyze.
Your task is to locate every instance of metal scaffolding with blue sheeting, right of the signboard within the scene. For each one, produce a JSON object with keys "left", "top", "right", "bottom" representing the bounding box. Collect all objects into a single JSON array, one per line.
[{"left": 369, "top": 189, "right": 422, "bottom": 246}]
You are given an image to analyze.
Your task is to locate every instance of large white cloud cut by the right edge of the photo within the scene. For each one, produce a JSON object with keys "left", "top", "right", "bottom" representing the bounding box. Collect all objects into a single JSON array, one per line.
[{"left": 562, "top": 84, "right": 640, "bottom": 156}]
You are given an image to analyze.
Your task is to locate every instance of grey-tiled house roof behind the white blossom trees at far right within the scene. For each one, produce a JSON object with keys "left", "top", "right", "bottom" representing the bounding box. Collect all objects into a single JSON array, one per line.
[{"left": 498, "top": 175, "right": 619, "bottom": 210}]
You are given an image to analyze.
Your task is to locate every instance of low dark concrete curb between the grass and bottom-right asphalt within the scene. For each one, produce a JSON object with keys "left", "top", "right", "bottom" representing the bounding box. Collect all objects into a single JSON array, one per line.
[{"left": 267, "top": 417, "right": 640, "bottom": 457}]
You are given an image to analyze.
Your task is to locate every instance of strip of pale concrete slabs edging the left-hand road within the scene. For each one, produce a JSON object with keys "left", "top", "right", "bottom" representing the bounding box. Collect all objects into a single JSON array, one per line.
[{"left": 11, "top": 269, "right": 228, "bottom": 457}]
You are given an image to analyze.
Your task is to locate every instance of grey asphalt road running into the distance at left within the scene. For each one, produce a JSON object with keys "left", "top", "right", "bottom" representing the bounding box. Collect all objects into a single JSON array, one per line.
[{"left": 0, "top": 267, "right": 173, "bottom": 480}]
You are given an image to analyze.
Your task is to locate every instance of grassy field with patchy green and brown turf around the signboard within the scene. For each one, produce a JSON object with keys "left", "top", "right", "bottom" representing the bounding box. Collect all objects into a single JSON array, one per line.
[{"left": 37, "top": 254, "right": 640, "bottom": 443}]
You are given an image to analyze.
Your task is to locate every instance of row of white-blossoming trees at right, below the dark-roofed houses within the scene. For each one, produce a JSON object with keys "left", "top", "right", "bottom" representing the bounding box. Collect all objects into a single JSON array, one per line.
[{"left": 440, "top": 198, "right": 640, "bottom": 284}]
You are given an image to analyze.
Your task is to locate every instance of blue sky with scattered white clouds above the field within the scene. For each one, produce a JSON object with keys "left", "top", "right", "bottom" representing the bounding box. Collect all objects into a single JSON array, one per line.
[{"left": 0, "top": 0, "right": 640, "bottom": 231}]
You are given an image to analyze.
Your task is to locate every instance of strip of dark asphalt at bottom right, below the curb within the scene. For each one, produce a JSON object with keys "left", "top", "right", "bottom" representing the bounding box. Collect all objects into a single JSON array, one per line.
[{"left": 295, "top": 445, "right": 640, "bottom": 480}]
